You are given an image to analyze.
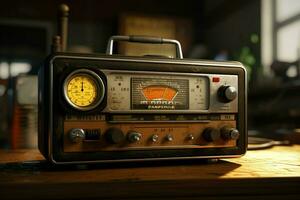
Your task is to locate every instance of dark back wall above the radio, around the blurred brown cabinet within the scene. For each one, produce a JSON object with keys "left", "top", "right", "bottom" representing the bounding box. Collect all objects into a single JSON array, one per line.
[{"left": 0, "top": 0, "right": 260, "bottom": 58}]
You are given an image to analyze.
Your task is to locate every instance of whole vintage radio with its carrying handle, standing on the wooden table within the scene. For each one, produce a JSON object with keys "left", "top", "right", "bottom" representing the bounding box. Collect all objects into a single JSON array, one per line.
[{"left": 39, "top": 4, "right": 247, "bottom": 164}]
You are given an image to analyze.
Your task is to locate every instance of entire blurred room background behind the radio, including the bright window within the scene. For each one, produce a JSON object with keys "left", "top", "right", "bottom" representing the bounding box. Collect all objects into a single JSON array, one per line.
[{"left": 0, "top": 0, "right": 300, "bottom": 149}]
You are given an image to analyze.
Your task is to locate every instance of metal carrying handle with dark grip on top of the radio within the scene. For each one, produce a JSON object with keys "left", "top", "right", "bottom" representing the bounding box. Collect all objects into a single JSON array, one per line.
[{"left": 106, "top": 35, "right": 183, "bottom": 59}]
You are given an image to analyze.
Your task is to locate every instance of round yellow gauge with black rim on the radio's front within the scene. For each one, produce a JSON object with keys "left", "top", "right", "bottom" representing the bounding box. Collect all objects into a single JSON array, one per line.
[{"left": 64, "top": 69, "right": 104, "bottom": 110}]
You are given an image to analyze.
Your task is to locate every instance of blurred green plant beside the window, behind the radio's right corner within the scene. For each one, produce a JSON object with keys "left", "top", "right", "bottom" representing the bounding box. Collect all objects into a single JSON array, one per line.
[{"left": 235, "top": 34, "right": 259, "bottom": 81}]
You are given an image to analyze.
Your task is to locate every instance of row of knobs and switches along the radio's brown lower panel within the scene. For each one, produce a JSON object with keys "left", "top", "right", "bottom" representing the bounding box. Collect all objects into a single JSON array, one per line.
[{"left": 69, "top": 127, "right": 240, "bottom": 144}]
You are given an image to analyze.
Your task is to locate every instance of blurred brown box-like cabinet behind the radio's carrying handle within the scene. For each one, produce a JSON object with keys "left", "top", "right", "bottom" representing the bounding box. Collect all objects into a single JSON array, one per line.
[{"left": 118, "top": 14, "right": 194, "bottom": 57}]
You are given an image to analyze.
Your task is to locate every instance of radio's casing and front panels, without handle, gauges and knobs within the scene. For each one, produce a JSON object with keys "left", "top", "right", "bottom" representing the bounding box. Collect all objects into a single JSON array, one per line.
[{"left": 38, "top": 53, "right": 247, "bottom": 164}]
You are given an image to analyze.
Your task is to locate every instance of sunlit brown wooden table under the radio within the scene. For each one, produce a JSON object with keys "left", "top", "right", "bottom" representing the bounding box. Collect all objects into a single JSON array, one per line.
[{"left": 0, "top": 145, "right": 300, "bottom": 200}]
